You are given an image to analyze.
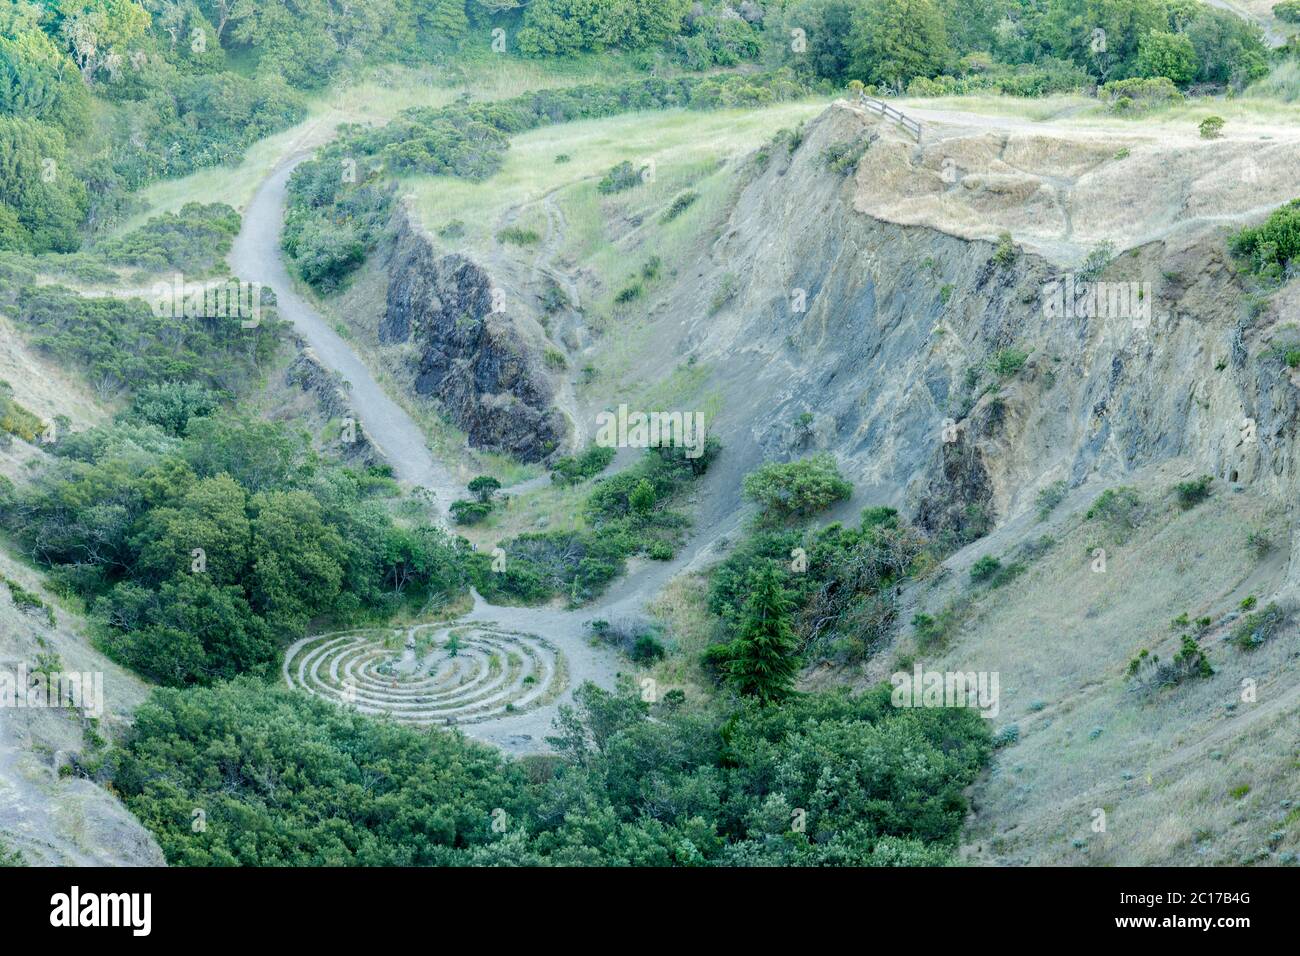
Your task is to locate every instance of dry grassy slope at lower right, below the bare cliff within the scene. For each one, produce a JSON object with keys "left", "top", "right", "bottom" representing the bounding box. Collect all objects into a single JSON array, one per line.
[{"left": 894, "top": 471, "right": 1300, "bottom": 865}]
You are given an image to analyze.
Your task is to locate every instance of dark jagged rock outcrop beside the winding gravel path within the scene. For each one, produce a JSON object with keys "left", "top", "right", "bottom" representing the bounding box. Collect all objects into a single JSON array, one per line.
[{"left": 380, "top": 216, "right": 566, "bottom": 462}]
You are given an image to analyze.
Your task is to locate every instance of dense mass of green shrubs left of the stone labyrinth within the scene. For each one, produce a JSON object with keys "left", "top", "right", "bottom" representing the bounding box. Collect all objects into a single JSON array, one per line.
[{"left": 4, "top": 408, "right": 478, "bottom": 685}]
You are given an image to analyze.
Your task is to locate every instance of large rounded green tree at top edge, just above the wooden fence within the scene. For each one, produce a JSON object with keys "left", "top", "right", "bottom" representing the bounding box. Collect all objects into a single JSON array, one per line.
[{"left": 850, "top": 0, "right": 950, "bottom": 88}]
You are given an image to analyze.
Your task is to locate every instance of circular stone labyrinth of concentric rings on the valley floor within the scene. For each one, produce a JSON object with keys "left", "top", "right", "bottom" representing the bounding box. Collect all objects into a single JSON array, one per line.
[{"left": 283, "top": 624, "right": 568, "bottom": 724}]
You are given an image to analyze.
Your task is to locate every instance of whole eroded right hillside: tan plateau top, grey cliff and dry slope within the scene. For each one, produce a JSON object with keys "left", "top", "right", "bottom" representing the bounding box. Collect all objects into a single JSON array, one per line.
[{"left": 387, "top": 103, "right": 1300, "bottom": 864}]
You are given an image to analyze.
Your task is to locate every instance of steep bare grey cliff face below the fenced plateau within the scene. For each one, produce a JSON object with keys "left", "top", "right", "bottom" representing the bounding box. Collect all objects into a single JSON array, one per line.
[{"left": 621, "top": 104, "right": 1297, "bottom": 540}]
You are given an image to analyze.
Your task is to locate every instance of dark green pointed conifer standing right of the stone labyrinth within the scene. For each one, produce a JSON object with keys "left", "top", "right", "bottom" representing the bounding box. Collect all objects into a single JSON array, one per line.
[{"left": 724, "top": 567, "right": 800, "bottom": 704}]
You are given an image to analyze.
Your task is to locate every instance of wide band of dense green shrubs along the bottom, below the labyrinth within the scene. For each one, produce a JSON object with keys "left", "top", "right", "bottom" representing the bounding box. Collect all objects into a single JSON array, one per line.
[{"left": 114, "top": 679, "right": 989, "bottom": 866}]
